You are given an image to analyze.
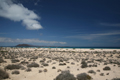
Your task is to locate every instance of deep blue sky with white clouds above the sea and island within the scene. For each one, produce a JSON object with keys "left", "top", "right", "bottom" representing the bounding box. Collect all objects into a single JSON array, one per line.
[{"left": 0, "top": 0, "right": 120, "bottom": 47}]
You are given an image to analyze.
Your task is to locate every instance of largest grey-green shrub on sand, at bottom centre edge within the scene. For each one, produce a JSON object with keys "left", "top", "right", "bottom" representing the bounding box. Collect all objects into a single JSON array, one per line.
[{"left": 55, "top": 71, "right": 76, "bottom": 80}]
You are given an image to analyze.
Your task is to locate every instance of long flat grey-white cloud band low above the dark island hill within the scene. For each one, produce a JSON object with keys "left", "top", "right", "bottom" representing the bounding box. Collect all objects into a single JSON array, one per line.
[{"left": 0, "top": 37, "right": 66, "bottom": 44}]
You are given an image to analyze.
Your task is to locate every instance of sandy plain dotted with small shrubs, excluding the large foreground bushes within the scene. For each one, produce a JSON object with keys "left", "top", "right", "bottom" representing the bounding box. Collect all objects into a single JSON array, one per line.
[{"left": 0, "top": 48, "right": 120, "bottom": 80}]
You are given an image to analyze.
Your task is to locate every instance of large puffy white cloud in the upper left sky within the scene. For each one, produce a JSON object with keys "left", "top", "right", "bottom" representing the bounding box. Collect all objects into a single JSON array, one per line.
[{"left": 0, "top": 0, "right": 42, "bottom": 30}]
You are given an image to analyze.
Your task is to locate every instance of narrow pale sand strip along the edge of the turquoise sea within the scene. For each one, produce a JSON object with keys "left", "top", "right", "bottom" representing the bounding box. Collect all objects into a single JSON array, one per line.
[{"left": 2, "top": 47, "right": 120, "bottom": 52}]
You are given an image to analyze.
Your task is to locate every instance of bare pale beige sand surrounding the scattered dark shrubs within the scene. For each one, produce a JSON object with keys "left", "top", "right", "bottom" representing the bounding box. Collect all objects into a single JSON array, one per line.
[{"left": 0, "top": 48, "right": 120, "bottom": 80}]
